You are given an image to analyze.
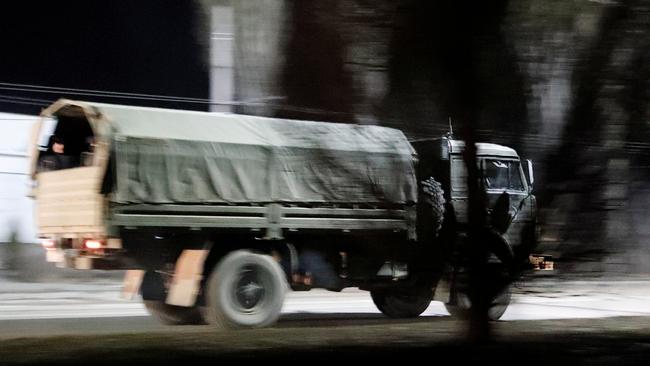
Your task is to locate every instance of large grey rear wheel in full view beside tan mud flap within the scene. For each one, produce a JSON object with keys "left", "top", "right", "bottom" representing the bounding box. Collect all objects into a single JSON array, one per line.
[{"left": 204, "top": 250, "right": 288, "bottom": 329}]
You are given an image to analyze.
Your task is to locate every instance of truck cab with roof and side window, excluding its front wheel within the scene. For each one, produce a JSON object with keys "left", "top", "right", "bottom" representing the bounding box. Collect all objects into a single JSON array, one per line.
[{"left": 411, "top": 137, "right": 537, "bottom": 258}]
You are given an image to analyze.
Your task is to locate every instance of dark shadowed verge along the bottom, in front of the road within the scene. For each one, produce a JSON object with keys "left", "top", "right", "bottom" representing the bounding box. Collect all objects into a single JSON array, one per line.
[{"left": 0, "top": 316, "right": 650, "bottom": 365}]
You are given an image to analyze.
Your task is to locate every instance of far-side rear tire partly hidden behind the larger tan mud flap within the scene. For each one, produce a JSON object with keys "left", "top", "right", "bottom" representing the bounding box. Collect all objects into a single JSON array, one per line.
[{"left": 141, "top": 271, "right": 205, "bottom": 325}]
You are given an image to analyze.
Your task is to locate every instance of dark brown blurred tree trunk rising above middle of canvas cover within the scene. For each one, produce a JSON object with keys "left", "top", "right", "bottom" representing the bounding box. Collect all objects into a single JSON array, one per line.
[{"left": 276, "top": 0, "right": 354, "bottom": 122}]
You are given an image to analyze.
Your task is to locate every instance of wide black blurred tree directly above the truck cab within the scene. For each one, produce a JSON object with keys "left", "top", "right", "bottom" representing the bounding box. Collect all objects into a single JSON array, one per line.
[{"left": 380, "top": 0, "right": 528, "bottom": 142}]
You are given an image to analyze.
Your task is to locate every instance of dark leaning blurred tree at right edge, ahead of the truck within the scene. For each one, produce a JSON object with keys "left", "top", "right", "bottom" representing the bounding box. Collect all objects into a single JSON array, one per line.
[{"left": 541, "top": 0, "right": 650, "bottom": 271}]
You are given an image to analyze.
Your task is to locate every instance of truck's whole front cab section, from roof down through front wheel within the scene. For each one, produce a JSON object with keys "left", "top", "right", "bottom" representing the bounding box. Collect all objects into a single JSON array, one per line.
[{"left": 412, "top": 136, "right": 545, "bottom": 320}]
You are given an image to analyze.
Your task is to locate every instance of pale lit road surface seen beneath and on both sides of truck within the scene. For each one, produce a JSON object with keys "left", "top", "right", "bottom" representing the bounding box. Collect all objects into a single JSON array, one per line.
[{"left": 0, "top": 279, "right": 650, "bottom": 339}]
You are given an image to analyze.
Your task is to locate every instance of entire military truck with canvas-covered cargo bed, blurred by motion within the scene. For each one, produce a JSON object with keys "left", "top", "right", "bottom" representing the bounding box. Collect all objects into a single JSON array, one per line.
[{"left": 31, "top": 99, "right": 536, "bottom": 328}]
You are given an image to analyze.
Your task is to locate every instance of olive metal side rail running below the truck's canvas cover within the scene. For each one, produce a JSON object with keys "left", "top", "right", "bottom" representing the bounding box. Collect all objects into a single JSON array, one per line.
[{"left": 108, "top": 203, "right": 416, "bottom": 240}]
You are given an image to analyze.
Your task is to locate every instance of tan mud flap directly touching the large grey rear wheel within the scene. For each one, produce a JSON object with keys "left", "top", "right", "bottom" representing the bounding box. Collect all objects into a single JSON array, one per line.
[{"left": 165, "top": 249, "right": 210, "bottom": 306}]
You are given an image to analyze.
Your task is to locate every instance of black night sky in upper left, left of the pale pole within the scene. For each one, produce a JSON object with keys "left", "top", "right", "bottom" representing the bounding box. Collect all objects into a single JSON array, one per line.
[{"left": 0, "top": 1, "right": 210, "bottom": 114}]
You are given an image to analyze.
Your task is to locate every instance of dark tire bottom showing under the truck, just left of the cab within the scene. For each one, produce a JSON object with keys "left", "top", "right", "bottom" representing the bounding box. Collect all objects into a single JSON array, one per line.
[{"left": 370, "top": 287, "right": 433, "bottom": 319}]
